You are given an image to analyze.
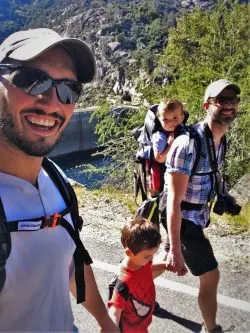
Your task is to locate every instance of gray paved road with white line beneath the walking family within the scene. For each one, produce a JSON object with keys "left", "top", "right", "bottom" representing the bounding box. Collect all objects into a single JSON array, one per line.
[{"left": 70, "top": 231, "right": 250, "bottom": 333}]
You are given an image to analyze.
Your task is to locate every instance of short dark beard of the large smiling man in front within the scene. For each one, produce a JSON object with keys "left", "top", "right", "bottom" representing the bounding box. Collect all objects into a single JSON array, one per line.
[{"left": 0, "top": 98, "right": 62, "bottom": 157}]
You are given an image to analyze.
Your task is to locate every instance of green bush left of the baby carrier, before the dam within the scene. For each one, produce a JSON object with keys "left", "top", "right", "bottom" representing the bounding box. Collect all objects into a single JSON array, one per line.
[{"left": 93, "top": 102, "right": 145, "bottom": 189}]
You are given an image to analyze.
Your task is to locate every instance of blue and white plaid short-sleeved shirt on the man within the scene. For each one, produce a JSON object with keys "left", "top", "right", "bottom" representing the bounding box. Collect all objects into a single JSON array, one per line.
[{"left": 165, "top": 122, "right": 224, "bottom": 228}]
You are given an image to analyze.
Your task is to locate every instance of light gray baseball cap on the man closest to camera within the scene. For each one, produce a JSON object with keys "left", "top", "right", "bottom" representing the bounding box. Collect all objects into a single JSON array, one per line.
[{"left": 0, "top": 28, "right": 96, "bottom": 83}]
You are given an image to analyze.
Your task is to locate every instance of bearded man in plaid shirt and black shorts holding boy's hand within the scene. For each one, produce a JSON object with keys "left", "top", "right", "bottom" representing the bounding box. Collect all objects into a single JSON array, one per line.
[{"left": 165, "top": 79, "right": 240, "bottom": 333}]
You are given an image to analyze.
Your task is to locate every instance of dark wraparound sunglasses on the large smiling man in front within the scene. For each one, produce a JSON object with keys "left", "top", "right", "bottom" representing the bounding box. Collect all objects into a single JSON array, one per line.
[{"left": 0, "top": 64, "right": 82, "bottom": 104}]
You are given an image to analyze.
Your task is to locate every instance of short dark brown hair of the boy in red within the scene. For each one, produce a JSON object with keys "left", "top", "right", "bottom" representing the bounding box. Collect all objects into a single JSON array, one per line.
[{"left": 121, "top": 217, "right": 161, "bottom": 254}]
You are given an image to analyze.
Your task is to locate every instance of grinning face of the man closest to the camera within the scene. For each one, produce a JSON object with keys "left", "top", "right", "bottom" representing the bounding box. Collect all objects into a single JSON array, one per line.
[{"left": 0, "top": 47, "right": 76, "bottom": 156}]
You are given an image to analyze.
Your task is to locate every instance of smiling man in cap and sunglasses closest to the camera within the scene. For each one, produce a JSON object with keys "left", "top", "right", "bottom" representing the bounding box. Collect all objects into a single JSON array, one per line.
[{"left": 0, "top": 29, "right": 119, "bottom": 332}]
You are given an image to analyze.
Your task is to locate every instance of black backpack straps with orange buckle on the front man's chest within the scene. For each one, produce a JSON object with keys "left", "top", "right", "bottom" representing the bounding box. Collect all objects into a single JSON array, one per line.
[{"left": 0, "top": 158, "right": 92, "bottom": 303}]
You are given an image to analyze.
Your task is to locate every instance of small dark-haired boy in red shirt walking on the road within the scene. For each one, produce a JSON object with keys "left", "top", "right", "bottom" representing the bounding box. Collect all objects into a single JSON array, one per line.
[{"left": 108, "top": 217, "right": 170, "bottom": 333}]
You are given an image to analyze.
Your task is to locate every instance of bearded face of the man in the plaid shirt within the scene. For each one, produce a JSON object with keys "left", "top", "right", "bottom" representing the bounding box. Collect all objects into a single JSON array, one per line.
[{"left": 205, "top": 88, "right": 239, "bottom": 126}]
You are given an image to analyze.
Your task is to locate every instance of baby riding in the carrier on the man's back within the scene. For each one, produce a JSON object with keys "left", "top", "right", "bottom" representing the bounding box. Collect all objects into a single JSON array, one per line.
[{"left": 147, "top": 99, "right": 185, "bottom": 196}]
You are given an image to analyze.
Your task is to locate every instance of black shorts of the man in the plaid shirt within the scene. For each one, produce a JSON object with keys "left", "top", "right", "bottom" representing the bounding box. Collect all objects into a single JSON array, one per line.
[{"left": 181, "top": 219, "right": 218, "bottom": 276}]
